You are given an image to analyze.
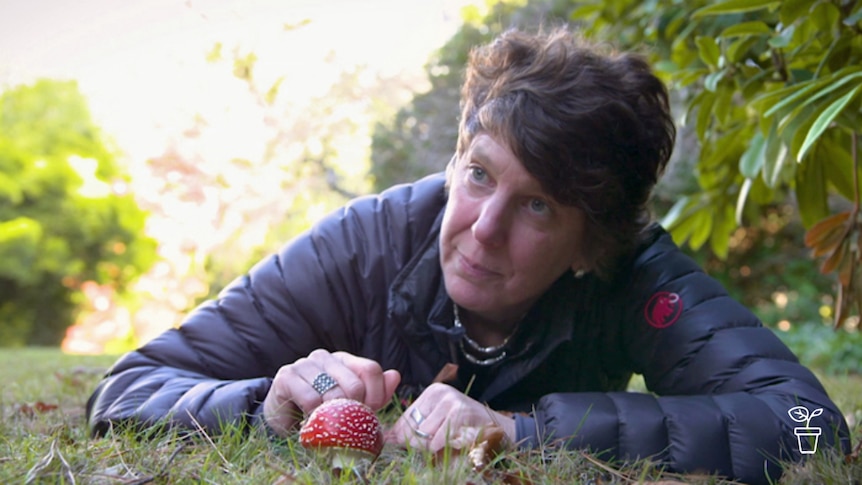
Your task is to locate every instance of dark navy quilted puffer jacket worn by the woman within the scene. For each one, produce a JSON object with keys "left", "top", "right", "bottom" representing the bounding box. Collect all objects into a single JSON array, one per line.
[{"left": 88, "top": 175, "right": 850, "bottom": 483}]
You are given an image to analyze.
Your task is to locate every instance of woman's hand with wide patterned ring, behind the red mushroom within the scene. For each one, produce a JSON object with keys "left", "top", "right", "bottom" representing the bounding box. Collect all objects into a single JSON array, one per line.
[{"left": 263, "top": 349, "right": 401, "bottom": 436}]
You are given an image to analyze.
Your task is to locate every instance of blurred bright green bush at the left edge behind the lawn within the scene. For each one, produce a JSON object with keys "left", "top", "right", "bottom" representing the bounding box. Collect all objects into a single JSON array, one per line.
[{"left": 0, "top": 80, "right": 155, "bottom": 346}]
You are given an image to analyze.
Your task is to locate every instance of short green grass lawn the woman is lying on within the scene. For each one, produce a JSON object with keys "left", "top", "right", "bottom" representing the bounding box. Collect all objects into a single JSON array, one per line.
[{"left": 0, "top": 349, "right": 862, "bottom": 485}]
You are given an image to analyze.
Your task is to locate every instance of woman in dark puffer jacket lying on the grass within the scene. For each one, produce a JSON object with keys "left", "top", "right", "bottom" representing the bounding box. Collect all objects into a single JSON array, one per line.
[{"left": 88, "top": 30, "right": 849, "bottom": 482}]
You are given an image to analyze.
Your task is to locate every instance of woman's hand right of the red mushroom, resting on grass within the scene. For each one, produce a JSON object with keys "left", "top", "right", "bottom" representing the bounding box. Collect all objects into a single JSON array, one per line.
[{"left": 386, "top": 383, "right": 516, "bottom": 453}]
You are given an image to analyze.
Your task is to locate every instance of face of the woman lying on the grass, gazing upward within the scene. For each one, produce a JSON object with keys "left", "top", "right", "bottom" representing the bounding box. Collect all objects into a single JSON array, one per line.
[{"left": 440, "top": 133, "right": 586, "bottom": 323}]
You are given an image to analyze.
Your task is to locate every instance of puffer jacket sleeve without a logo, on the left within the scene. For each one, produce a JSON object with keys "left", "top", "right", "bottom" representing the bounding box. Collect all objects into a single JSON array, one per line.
[{"left": 87, "top": 174, "right": 444, "bottom": 434}]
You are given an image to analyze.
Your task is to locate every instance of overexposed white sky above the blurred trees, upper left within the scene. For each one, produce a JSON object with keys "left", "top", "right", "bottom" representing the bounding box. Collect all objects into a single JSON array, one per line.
[{"left": 0, "top": 0, "right": 483, "bottom": 156}]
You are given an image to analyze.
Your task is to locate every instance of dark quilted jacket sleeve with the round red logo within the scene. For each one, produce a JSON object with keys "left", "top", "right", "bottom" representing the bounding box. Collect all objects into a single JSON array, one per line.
[{"left": 518, "top": 228, "right": 850, "bottom": 483}]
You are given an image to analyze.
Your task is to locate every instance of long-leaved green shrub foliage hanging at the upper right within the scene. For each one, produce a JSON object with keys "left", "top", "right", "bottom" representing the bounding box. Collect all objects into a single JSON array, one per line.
[{"left": 571, "top": 0, "right": 862, "bottom": 326}]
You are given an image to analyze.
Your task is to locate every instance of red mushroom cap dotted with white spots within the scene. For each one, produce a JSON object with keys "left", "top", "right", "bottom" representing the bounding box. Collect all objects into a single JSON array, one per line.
[{"left": 299, "top": 398, "right": 383, "bottom": 458}]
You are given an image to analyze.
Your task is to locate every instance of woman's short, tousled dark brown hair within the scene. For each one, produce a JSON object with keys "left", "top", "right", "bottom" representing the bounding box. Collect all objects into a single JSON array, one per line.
[{"left": 457, "top": 27, "right": 676, "bottom": 277}]
